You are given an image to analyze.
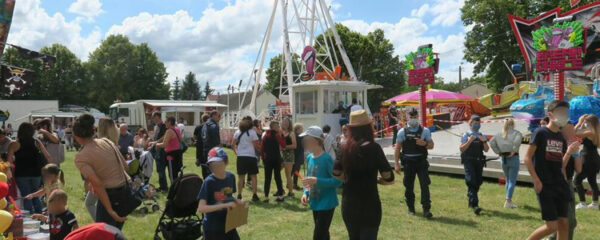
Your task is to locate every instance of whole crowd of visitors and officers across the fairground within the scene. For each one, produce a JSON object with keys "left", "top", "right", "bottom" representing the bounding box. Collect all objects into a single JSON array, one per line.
[{"left": 0, "top": 98, "right": 600, "bottom": 240}]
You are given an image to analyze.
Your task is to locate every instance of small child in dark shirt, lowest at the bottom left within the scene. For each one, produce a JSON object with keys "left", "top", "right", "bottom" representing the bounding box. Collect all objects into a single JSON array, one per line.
[{"left": 32, "top": 189, "right": 78, "bottom": 240}]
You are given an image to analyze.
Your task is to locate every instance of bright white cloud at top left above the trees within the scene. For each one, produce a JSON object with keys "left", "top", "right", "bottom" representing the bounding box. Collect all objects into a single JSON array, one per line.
[{"left": 7, "top": 0, "right": 101, "bottom": 60}]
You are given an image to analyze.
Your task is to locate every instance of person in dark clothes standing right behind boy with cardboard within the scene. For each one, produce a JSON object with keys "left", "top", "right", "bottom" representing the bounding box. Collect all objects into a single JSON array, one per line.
[{"left": 200, "top": 110, "right": 221, "bottom": 178}]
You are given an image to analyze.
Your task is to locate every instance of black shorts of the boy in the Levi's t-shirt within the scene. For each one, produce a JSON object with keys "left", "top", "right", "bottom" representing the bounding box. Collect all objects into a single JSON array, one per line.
[{"left": 537, "top": 185, "right": 572, "bottom": 221}]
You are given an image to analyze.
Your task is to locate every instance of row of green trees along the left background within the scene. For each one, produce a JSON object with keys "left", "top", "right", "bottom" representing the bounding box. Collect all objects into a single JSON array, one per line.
[{"left": 2, "top": 35, "right": 214, "bottom": 111}]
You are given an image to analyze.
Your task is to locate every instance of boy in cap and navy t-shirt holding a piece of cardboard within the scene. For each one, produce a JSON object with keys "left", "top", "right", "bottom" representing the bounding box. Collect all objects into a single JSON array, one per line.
[{"left": 198, "top": 147, "right": 243, "bottom": 240}]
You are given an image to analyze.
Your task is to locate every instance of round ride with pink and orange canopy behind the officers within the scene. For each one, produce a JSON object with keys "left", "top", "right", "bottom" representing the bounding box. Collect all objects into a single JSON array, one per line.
[{"left": 383, "top": 89, "right": 490, "bottom": 129}]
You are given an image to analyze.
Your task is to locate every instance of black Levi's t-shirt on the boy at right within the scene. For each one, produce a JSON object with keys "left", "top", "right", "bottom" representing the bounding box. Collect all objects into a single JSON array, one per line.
[{"left": 530, "top": 127, "right": 567, "bottom": 185}]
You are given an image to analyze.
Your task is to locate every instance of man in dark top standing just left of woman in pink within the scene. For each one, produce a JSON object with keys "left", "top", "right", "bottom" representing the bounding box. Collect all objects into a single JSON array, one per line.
[{"left": 148, "top": 112, "right": 169, "bottom": 192}]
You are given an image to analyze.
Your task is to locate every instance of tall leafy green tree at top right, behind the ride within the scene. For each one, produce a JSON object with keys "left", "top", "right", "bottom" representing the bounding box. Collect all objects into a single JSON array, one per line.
[{"left": 461, "top": 0, "right": 593, "bottom": 91}]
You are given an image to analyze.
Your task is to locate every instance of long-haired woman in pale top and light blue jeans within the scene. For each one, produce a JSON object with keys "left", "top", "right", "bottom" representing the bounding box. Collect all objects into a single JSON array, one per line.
[{"left": 490, "top": 118, "right": 523, "bottom": 208}]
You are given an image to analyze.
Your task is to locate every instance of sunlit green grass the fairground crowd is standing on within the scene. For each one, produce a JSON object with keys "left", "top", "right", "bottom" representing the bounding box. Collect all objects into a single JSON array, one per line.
[{"left": 62, "top": 148, "right": 600, "bottom": 240}]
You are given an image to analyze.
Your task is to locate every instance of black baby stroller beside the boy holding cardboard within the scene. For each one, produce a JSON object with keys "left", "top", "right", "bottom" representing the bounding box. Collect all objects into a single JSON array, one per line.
[{"left": 154, "top": 169, "right": 204, "bottom": 240}]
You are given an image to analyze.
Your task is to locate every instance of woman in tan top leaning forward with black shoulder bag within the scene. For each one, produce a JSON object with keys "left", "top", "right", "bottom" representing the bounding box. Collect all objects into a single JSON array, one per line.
[{"left": 73, "top": 114, "right": 131, "bottom": 229}]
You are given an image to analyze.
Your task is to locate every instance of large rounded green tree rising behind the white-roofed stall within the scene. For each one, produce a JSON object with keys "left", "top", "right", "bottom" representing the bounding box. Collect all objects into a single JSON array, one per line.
[{"left": 84, "top": 35, "right": 169, "bottom": 111}]
